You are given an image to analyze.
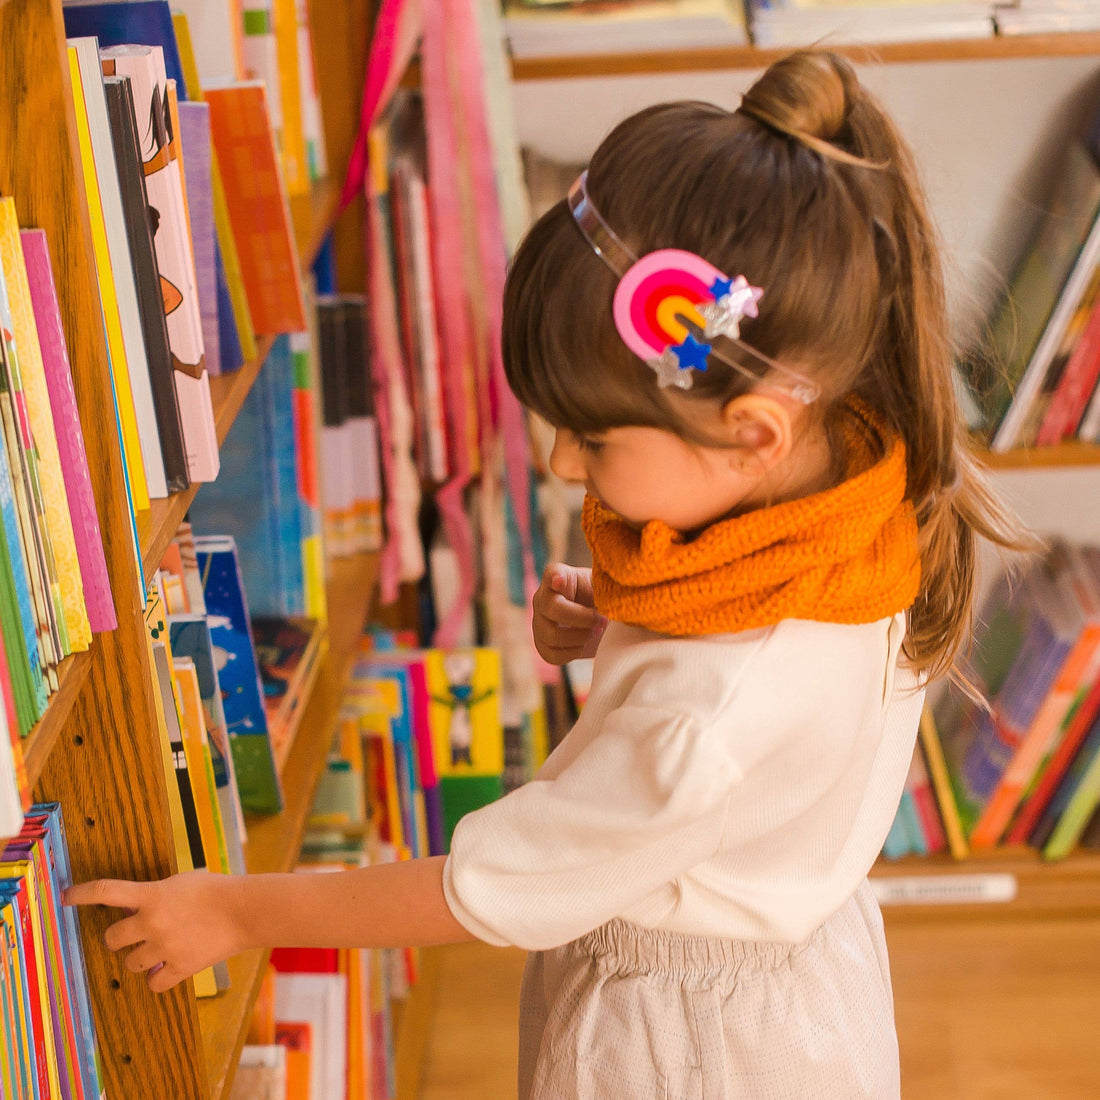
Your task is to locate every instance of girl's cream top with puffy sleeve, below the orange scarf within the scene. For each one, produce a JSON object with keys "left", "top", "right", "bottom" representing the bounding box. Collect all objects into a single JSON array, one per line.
[{"left": 443, "top": 614, "right": 924, "bottom": 950}]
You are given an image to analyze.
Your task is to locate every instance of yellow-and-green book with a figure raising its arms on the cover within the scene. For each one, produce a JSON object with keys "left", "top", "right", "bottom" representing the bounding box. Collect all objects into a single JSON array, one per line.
[{"left": 425, "top": 648, "right": 504, "bottom": 846}]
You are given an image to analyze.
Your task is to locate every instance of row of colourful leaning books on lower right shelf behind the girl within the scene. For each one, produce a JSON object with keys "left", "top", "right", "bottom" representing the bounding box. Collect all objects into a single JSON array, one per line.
[{"left": 886, "top": 542, "right": 1100, "bottom": 859}]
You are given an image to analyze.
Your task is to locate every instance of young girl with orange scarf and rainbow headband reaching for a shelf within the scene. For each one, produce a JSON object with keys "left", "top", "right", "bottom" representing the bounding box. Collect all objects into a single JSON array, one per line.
[{"left": 68, "top": 51, "right": 1019, "bottom": 1100}]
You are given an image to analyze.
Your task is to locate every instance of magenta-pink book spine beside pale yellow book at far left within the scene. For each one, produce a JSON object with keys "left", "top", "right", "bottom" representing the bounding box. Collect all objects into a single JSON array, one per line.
[{"left": 20, "top": 229, "right": 118, "bottom": 634}]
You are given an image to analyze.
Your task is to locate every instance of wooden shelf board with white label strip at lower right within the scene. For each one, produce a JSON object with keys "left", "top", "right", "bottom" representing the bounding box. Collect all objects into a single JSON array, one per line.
[{"left": 871, "top": 847, "right": 1100, "bottom": 923}]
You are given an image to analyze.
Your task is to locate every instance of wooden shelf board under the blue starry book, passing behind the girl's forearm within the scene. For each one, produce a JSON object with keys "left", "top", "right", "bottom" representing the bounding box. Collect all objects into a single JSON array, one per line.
[{"left": 198, "top": 553, "right": 377, "bottom": 1100}]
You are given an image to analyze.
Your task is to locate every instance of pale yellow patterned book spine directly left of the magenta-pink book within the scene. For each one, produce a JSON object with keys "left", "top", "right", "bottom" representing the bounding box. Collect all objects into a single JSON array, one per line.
[{"left": 0, "top": 198, "right": 91, "bottom": 652}]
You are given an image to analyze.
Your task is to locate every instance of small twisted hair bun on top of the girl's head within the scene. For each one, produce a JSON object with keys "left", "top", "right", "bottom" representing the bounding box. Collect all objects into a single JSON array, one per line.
[{"left": 740, "top": 50, "right": 860, "bottom": 160}]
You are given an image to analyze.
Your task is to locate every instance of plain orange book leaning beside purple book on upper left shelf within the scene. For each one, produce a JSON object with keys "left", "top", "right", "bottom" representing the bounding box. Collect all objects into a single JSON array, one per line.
[{"left": 206, "top": 81, "right": 307, "bottom": 334}]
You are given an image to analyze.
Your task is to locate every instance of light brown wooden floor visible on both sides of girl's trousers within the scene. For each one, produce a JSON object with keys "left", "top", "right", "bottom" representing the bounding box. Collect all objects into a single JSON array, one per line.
[{"left": 418, "top": 920, "right": 1100, "bottom": 1100}]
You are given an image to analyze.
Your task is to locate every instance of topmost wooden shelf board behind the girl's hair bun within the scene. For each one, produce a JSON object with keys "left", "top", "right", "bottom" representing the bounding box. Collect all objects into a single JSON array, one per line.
[{"left": 512, "top": 32, "right": 1100, "bottom": 80}]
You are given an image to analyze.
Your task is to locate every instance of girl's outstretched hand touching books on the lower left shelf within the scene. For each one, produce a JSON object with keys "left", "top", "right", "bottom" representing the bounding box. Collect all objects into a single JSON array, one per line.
[{"left": 64, "top": 871, "right": 246, "bottom": 993}]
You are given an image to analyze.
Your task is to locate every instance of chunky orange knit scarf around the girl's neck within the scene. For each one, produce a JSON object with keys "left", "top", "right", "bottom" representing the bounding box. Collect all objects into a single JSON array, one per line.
[{"left": 583, "top": 408, "right": 921, "bottom": 636}]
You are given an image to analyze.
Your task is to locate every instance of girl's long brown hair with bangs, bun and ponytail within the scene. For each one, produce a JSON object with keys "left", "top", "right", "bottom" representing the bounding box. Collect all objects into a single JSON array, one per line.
[{"left": 503, "top": 50, "right": 1032, "bottom": 675}]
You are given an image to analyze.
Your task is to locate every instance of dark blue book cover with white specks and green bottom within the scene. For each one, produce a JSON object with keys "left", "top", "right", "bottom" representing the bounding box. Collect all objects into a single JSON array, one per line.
[{"left": 195, "top": 537, "right": 283, "bottom": 813}]
